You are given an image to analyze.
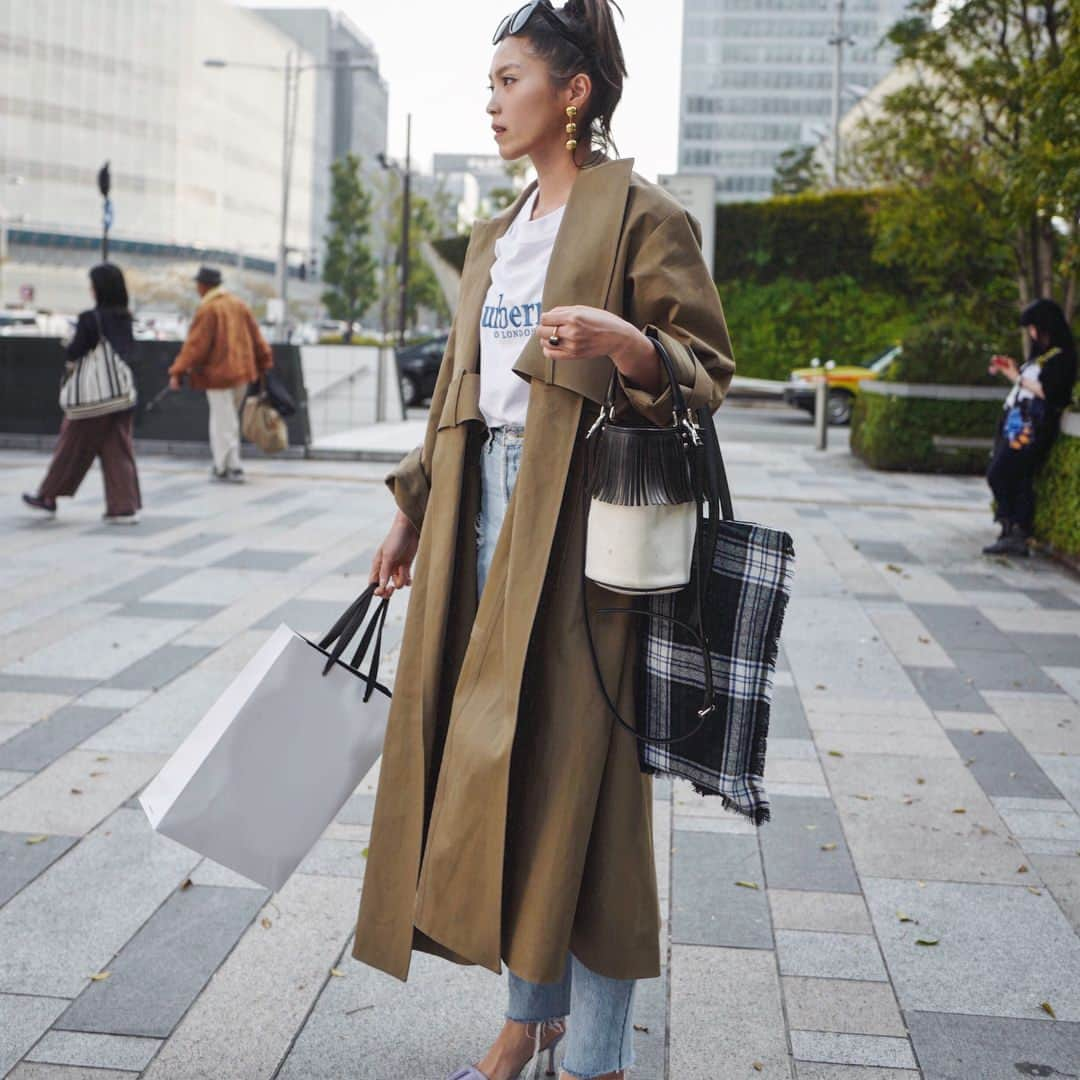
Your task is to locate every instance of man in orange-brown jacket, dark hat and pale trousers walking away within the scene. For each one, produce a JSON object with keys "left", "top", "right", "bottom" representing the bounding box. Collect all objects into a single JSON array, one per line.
[{"left": 168, "top": 267, "right": 273, "bottom": 484}]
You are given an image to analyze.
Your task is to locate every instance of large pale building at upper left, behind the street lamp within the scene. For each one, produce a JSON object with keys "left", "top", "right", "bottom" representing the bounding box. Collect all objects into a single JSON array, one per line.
[{"left": 0, "top": 0, "right": 314, "bottom": 261}]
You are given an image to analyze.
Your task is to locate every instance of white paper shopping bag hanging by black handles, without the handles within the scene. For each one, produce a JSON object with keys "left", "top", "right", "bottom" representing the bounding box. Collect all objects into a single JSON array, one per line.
[{"left": 139, "top": 624, "right": 390, "bottom": 891}]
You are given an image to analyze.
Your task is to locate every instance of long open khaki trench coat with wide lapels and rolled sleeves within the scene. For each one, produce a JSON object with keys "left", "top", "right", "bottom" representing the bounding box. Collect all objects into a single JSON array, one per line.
[{"left": 353, "top": 159, "right": 734, "bottom": 983}]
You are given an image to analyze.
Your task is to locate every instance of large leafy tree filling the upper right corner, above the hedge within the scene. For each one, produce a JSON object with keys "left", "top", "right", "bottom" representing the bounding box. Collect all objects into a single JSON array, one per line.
[{"left": 855, "top": 0, "right": 1080, "bottom": 316}]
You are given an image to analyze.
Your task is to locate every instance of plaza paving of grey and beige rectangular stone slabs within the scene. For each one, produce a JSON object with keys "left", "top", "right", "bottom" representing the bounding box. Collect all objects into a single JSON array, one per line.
[{"left": 0, "top": 418, "right": 1080, "bottom": 1080}]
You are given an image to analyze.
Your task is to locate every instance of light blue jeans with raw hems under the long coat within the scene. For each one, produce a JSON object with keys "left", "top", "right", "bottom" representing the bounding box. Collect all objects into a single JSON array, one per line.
[{"left": 476, "top": 428, "right": 637, "bottom": 1078}]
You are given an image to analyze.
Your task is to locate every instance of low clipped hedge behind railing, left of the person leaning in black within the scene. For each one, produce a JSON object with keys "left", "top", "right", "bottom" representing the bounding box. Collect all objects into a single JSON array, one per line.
[{"left": 851, "top": 393, "right": 1001, "bottom": 474}]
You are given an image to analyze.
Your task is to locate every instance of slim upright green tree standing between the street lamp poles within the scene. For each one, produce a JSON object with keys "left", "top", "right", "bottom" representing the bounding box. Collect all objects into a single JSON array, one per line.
[{"left": 323, "top": 153, "right": 376, "bottom": 343}]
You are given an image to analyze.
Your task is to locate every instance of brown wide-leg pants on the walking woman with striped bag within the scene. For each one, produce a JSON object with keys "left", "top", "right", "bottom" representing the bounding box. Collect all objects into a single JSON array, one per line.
[{"left": 38, "top": 409, "right": 143, "bottom": 516}]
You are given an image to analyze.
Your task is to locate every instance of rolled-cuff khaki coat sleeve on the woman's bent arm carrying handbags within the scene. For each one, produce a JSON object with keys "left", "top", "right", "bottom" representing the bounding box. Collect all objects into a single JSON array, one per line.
[{"left": 618, "top": 210, "right": 735, "bottom": 426}]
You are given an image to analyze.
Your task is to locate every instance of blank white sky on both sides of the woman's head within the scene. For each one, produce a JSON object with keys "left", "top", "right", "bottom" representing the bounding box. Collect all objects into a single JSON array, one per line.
[{"left": 245, "top": 0, "right": 683, "bottom": 179}]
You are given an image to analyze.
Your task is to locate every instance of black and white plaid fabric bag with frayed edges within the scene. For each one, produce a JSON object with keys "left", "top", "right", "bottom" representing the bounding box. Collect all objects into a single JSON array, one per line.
[{"left": 637, "top": 521, "right": 795, "bottom": 825}]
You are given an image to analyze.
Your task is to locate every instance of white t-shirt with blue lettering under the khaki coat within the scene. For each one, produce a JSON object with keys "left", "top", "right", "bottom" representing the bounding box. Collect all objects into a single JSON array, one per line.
[{"left": 480, "top": 189, "right": 566, "bottom": 428}]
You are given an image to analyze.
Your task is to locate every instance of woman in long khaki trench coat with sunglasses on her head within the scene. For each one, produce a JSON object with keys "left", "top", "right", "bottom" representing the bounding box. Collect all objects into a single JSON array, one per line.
[{"left": 353, "top": 0, "right": 734, "bottom": 1080}]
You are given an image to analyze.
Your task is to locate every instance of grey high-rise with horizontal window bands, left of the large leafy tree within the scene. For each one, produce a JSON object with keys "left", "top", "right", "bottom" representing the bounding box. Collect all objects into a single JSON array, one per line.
[{"left": 678, "top": 0, "right": 906, "bottom": 202}]
